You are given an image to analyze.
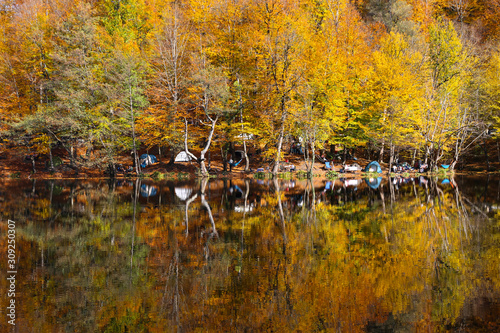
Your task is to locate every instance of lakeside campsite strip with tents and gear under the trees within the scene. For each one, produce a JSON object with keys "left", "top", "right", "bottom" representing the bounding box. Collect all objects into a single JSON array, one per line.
[{"left": 0, "top": 139, "right": 494, "bottom": 179}]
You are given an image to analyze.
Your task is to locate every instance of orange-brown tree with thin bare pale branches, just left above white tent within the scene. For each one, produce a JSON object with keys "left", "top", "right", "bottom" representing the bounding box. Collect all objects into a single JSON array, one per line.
[{"left": 140, "top": 2, "right": 193, "bottom": 163}]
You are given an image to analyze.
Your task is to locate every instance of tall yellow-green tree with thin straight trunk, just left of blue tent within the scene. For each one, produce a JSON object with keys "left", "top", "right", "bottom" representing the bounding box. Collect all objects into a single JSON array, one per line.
[{"left": 100, "top": 0, "right": 151, "bottom": 174}]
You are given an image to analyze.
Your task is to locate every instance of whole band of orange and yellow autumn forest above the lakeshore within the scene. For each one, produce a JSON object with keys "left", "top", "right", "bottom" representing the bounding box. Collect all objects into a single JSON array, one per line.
[{"left": 0, "top": 0, "right": 500, "bottom": 175}]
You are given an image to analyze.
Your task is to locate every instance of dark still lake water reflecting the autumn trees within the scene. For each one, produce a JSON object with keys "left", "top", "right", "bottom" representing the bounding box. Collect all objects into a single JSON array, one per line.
[{"left": 0, "top": 177, "right": 500, "bottom": 332}]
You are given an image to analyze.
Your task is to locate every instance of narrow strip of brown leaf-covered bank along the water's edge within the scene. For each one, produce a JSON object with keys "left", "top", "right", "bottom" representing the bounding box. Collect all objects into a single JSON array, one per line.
[{"left": 0, "top": 153, "right": 500, "bottom": 181}]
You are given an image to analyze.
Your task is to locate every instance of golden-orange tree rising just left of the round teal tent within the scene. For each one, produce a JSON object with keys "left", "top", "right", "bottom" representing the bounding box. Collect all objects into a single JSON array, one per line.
[{"left": 324, "top": 1, "right": 371, "bottom": 161}]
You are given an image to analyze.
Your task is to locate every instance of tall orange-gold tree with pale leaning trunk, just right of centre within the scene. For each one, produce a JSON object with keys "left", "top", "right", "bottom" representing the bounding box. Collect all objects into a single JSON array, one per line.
[{"left": 253, "top": 0, "right": 303, "bottom": 174}]
